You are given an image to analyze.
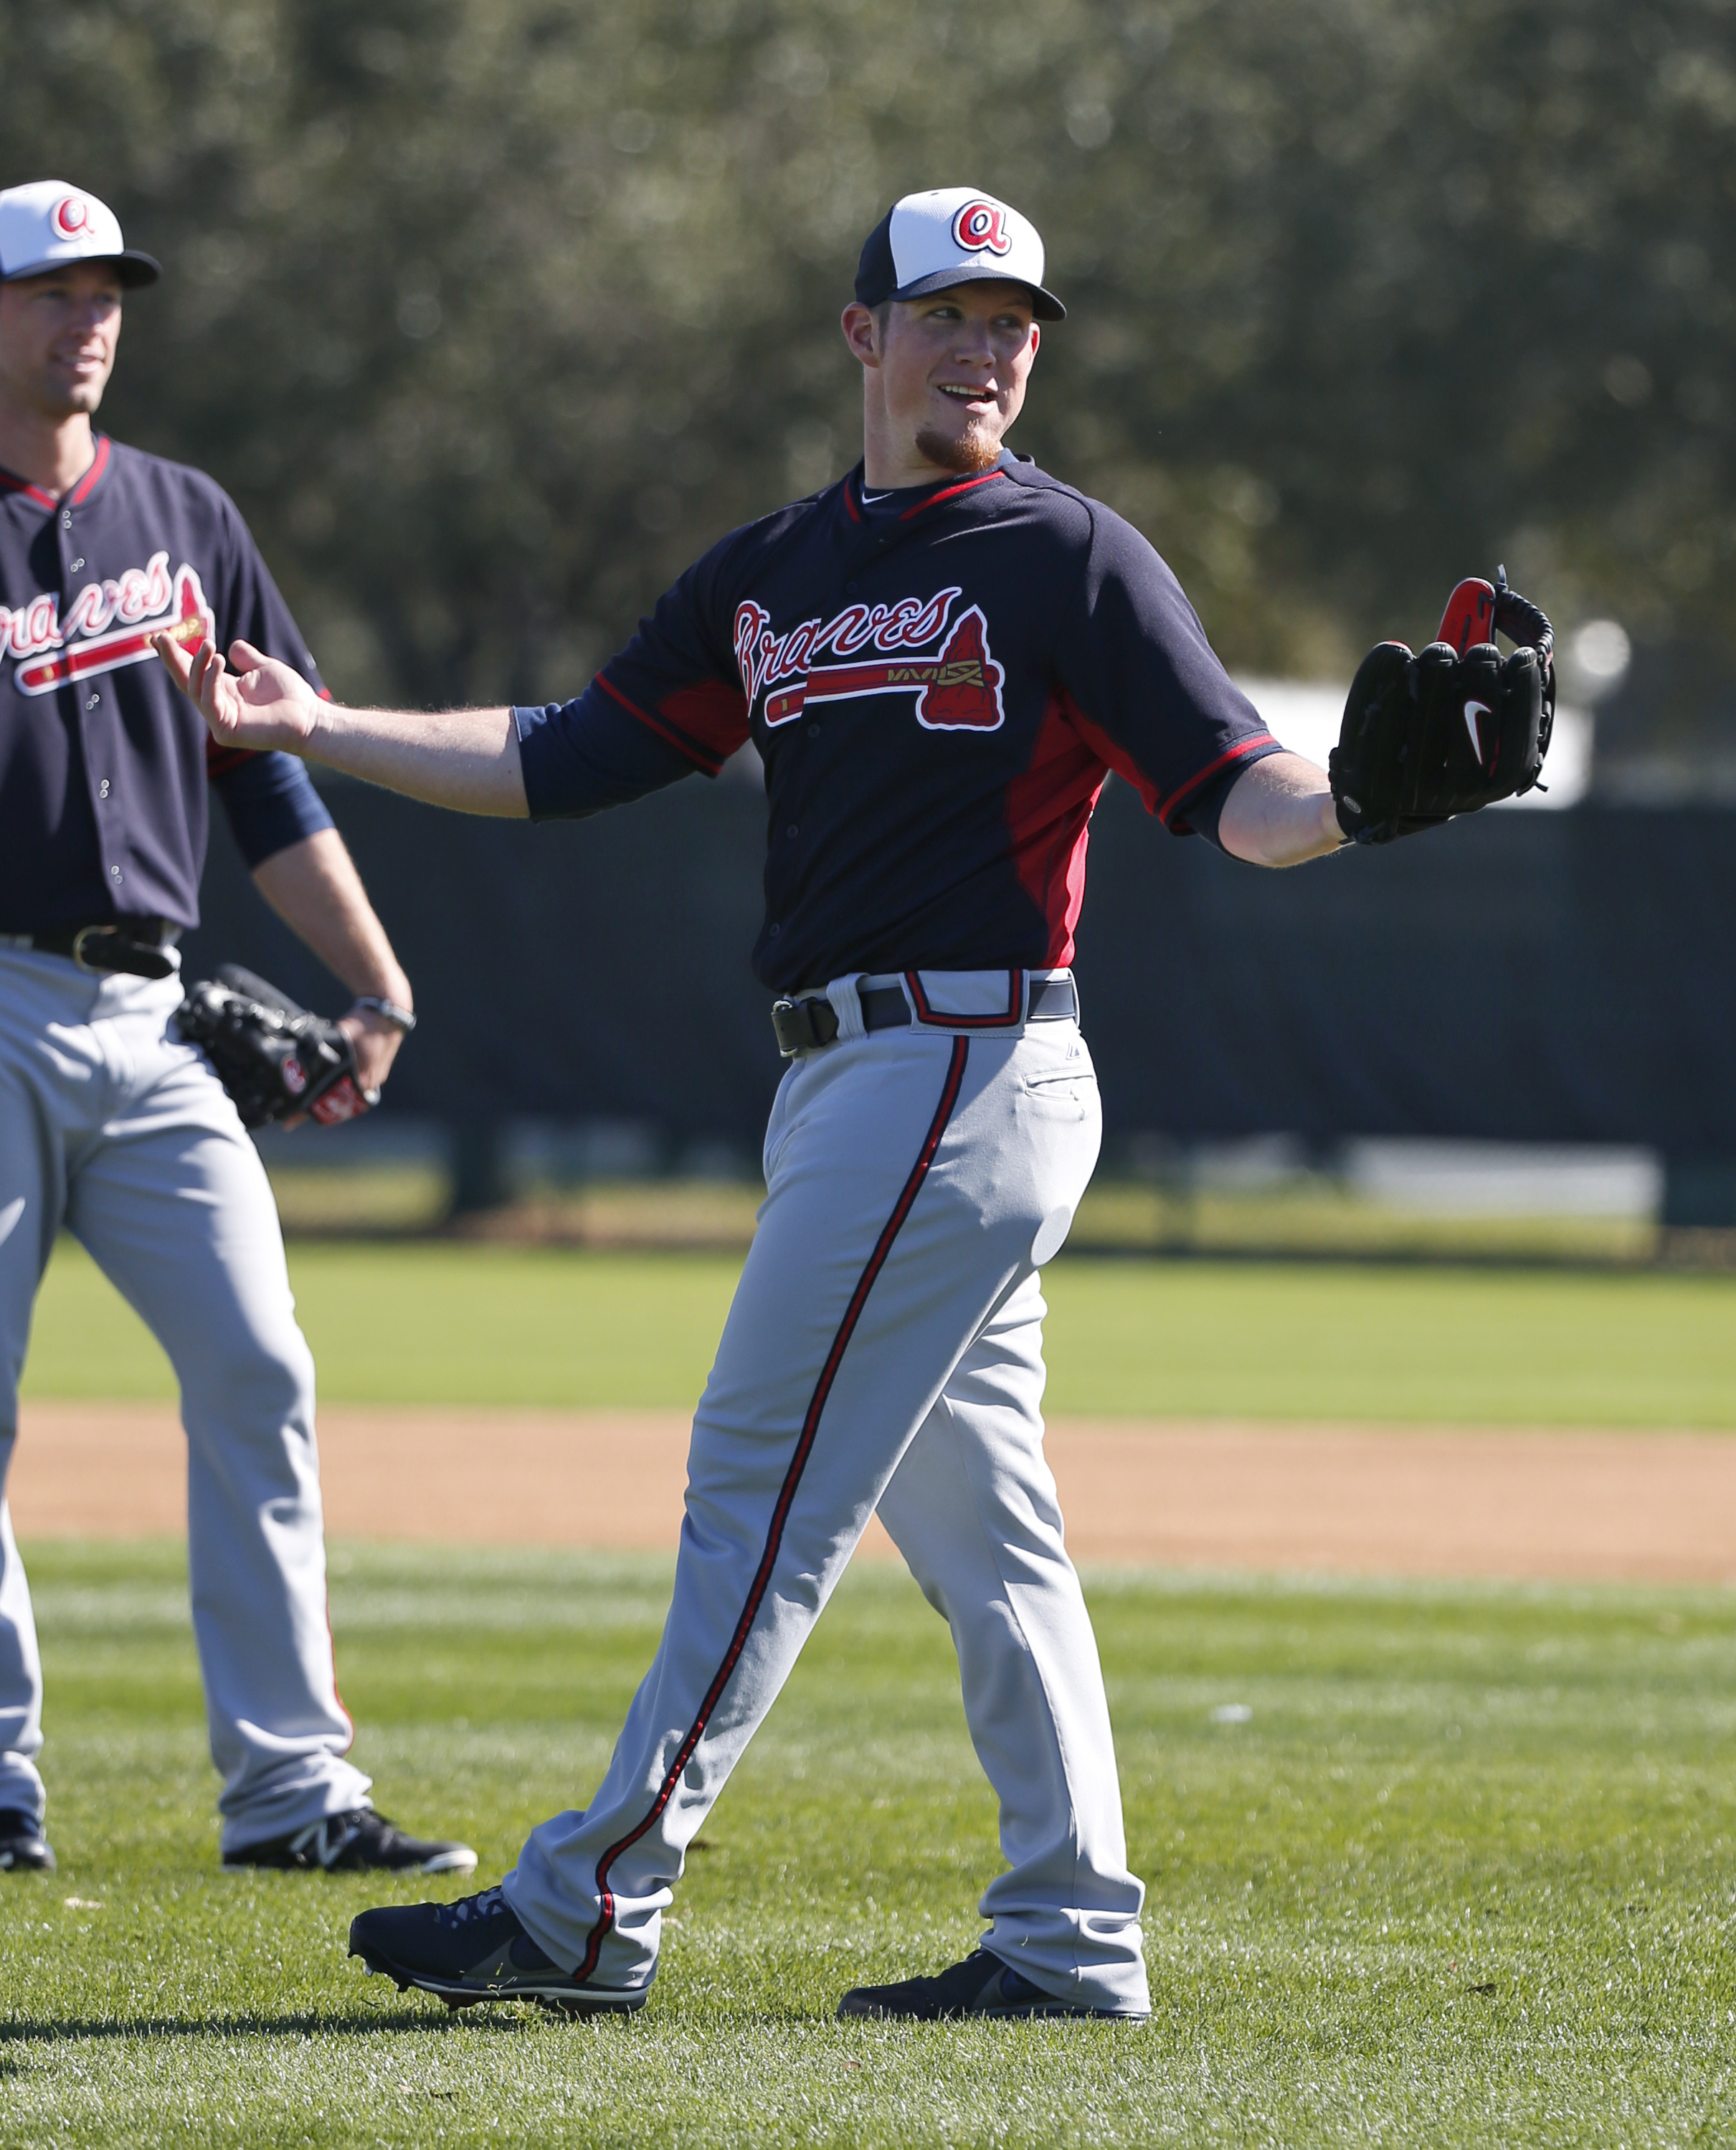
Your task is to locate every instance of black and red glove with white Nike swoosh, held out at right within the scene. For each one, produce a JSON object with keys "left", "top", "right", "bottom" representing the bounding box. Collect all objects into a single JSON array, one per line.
[{"left": 1328, "top": 567, "right": 1555, "bottom": 843}]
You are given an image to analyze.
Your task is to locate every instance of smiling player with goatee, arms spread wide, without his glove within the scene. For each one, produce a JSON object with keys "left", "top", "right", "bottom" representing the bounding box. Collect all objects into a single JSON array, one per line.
[{"left": 161, "top": 189, "right": 1555, "bottom": 2019}]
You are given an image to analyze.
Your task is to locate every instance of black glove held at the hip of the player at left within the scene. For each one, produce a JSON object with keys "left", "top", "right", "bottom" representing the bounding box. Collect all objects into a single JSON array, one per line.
[{"left": 174, "top": 963, "right": 380, "bottom": 1127}]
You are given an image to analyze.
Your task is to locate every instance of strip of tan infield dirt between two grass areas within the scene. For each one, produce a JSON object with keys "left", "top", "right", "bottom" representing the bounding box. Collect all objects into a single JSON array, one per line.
[{"left": 9, "top": 1402, "right": 1736, "bottom": 1583}]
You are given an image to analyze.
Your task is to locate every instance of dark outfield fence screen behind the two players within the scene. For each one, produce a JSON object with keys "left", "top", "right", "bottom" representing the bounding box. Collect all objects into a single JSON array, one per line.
[{"left": 187, "top": 780, "right": 1736, "bottom": 1223}]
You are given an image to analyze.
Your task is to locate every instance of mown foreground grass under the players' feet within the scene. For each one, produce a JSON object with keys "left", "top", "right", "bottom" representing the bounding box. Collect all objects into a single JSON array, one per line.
[{"left": 0, "top": 1544, "right": 1736, "bottom": 2150}]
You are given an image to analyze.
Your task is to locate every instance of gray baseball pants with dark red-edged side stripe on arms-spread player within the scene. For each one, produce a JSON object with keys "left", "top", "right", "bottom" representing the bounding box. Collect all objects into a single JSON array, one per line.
[{"left": 503, "top": 972, "right": 1149, "bottom": 2017}]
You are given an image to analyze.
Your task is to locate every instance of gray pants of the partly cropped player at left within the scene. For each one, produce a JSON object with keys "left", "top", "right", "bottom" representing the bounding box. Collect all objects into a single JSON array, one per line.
[{"left": 0, "top": 948, "right": 369, "bottom": 1851}]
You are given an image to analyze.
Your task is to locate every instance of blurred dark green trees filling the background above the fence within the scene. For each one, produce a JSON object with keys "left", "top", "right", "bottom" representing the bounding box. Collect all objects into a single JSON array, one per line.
[{"left": 0, "top": 0, "right": 1736, "bottom": 701}]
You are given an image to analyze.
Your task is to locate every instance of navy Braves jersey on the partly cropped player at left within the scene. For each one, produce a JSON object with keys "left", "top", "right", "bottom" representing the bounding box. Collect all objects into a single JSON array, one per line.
[{"left": 0, "top": 435, "right": 331, "bottom": 933}]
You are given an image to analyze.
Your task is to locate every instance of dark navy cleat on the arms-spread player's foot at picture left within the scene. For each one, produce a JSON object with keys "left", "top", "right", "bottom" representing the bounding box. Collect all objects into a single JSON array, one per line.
[{"left": 350, "top": 1888, "right": 651, "bottom": 2014}]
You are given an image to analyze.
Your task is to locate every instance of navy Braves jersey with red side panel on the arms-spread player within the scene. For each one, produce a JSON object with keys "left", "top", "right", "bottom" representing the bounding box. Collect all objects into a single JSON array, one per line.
[{"left": 513, "top": 454, "right": 1279, "bottom": 991}]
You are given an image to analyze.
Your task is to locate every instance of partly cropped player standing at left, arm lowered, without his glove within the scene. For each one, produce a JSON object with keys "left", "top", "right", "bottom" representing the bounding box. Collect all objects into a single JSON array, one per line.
[{"left": 0, "top": 181, "right": 475, "bottom": 1872}]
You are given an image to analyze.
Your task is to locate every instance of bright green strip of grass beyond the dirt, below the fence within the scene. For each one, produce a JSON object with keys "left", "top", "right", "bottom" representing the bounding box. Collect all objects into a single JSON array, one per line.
[{"left": 26, "top": 1243, "right": 1736, "bottom": 1428}]
